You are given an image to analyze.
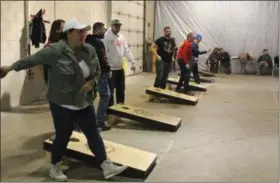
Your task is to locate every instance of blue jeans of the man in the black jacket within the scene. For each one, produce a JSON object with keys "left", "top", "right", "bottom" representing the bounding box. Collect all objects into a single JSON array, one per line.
[{"left": 97, "top": 73, "right": 110, "bottom": 125}]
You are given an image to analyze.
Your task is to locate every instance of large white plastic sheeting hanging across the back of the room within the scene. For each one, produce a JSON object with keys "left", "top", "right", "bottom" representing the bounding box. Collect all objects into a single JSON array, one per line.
[{"left": 155, "top": 1, "right": 279, "bottom": 69}]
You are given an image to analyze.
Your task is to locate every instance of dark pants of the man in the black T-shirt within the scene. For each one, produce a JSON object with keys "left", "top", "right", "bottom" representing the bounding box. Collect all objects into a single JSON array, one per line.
[{"left": 154, "top": 61, "right": 172, "bottom": 89}]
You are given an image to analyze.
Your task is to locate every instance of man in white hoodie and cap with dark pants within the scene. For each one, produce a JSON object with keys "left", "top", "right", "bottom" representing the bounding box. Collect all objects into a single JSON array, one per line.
[{"left": 103, "top": 19, "right": 136, "bottom": 107}]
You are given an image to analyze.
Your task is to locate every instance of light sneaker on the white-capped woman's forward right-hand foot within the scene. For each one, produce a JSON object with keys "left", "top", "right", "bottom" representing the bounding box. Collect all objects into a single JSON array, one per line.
[{"left": 101, "top": 160, "right": 128, "bottom": 179}]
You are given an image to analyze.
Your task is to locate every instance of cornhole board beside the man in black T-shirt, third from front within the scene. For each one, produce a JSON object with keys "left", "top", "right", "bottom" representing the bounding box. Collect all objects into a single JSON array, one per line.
[{"left": 146, "top": 87, "right": 198, "bottom": 105}]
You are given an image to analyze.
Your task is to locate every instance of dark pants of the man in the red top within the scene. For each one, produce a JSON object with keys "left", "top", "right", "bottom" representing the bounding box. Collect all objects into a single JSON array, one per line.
[{"left": 176, "top": 59, "right": 191, "bottom": 92}]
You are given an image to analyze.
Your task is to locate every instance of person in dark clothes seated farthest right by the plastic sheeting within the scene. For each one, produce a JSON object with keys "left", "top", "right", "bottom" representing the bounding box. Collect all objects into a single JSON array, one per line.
[{"left": 257, "top": 49, "right": 272, "bottom": 75}]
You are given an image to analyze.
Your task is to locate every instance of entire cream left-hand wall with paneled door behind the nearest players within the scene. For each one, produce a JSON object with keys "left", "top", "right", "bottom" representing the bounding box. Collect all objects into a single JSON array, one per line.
[{"left": 1, "top": 0, "right": 154, "bottom": 109}]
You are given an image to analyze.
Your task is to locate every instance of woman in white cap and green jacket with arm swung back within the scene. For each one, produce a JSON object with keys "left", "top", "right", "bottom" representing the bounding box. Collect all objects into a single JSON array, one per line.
[{"left": 0, "top": 20, "right": 127, "bottom": 181}]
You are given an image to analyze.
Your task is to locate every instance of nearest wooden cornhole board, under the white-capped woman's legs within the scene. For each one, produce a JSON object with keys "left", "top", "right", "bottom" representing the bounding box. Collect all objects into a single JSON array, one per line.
[{"left": 44, "top": 132, "right": 157, "bottom": 179}]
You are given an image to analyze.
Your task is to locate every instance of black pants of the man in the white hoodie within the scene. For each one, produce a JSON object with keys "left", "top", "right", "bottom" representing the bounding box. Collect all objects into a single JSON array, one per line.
[{"left": 108, "top": 69, "right": 125, "bottom": 107}]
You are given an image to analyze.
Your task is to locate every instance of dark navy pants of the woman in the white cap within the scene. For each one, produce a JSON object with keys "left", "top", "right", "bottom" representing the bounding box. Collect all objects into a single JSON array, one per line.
[{"left": 49, "top": 102, "right": 107, "bottom": 164}]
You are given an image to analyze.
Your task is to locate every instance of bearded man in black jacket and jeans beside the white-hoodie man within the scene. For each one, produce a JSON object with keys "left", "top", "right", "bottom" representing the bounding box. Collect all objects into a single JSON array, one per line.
[{"left": 85, "top": 22, "right": 111, "bottom": 131}]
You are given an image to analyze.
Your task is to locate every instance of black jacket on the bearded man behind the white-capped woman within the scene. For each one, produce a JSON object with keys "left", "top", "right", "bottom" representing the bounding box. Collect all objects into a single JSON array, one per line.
[{"left": 85, "top": 35, "right": 111, "bottom": 73}]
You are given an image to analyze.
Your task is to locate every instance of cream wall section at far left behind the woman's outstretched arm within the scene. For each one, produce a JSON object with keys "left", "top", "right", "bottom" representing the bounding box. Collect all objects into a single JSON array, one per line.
[{"left": 1, "top": 1, "right": 25, "bottom": 107}]
